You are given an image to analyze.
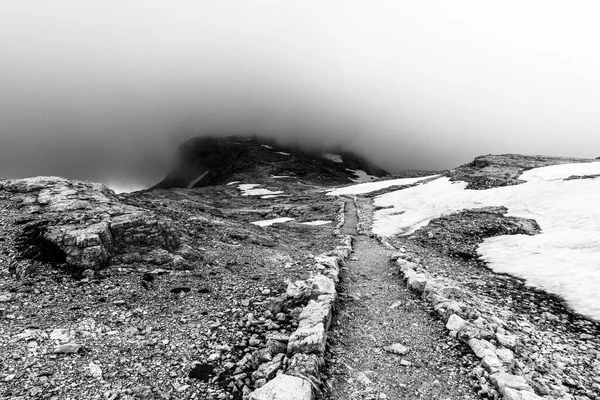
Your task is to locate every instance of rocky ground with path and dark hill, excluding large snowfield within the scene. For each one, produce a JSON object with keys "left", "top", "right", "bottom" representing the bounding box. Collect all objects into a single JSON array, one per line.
[{"left": 0, "top": 137, "right": 600, "bottom": 400}]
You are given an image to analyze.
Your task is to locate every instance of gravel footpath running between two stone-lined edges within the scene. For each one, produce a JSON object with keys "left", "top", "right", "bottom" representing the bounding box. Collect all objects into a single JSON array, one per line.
[{"left": 328, "top": 201, "right": 477, "bottom": 400}]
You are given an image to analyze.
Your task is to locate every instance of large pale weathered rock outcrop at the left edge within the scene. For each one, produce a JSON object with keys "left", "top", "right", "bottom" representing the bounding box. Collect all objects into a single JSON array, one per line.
[{"left": 0, "top": 177, "right": 180, "bottom": 269}]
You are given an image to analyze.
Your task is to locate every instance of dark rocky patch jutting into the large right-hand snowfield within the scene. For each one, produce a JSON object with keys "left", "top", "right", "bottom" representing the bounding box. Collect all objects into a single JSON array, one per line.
[{"left": 413, "top": 207, "right": 540, "bottom": 260}]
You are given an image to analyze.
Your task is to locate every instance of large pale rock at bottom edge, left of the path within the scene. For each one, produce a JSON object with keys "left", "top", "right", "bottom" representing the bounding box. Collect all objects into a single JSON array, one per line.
[{"left": 249, "top": 374, "right": 314, "bottom": 400}]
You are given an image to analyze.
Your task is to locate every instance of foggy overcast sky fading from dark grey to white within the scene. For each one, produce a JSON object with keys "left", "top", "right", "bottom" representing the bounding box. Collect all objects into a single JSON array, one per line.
[{"left": 0, "top": 0, "right": 600, "bottom": 191}]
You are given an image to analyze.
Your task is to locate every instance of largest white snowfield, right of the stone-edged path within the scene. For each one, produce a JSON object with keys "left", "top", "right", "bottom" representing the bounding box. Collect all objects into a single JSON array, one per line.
[{"left": 373, "top": 162, "right": 600, "bottom": 320}]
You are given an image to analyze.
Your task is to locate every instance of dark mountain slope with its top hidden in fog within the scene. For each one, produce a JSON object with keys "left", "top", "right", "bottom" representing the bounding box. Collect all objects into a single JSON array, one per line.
[{"left": 151, "top": 136, "right": 388, "bottom": 189}]
